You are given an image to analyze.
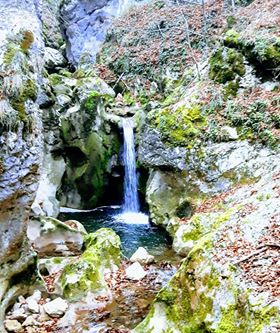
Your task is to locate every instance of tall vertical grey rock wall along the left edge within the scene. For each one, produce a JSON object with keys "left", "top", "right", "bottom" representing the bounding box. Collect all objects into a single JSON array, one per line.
[{"left": 0, "top": 1, "right": 43, "bottom": 331}]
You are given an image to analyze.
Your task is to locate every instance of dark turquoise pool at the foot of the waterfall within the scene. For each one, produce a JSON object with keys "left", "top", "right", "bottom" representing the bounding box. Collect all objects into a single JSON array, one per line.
[{"left": 59, "top": 207, "right": 173, "bottom": 261}]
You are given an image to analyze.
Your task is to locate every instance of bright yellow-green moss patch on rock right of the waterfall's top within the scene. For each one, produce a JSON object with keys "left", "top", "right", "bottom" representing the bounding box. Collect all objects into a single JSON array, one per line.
[{"left": 149, "top": 105, "right": 206, "bottom": 148}]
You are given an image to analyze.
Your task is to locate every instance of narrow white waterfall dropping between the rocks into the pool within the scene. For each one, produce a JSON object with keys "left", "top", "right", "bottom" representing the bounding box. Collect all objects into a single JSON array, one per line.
[{"left": 122, "top": 118, "right": 139, "bottom": 213}]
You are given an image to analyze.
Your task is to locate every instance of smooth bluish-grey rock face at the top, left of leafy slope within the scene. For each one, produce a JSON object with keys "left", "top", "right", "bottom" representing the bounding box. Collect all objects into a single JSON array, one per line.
[{"left": 61, "top": 0, "right": 149, "bottom": 65}]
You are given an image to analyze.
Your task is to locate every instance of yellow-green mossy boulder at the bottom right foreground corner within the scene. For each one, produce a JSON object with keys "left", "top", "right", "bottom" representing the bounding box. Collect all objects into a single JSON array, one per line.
[{"left": 133, "top": 247, "right": 278, "bottom": 333}]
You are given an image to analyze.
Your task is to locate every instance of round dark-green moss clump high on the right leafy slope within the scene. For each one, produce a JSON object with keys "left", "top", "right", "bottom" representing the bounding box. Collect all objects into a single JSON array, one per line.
[{"left": 209, "top": 47, "right": 245, "bottom": 84}]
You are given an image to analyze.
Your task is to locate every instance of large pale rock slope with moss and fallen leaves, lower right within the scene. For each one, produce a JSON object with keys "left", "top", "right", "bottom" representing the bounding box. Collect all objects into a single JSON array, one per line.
[{"left": 133, "top": 150, "right": 280, "bottom": 333}]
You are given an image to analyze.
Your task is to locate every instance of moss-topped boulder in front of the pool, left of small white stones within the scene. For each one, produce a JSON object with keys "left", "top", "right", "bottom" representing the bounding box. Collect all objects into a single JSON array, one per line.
[{"left": 58, "top": 228, "right": 121, "bottom": 300}]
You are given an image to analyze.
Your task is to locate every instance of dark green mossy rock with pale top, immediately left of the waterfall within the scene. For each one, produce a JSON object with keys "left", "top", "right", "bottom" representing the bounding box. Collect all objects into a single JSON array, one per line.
[{"left": 48, "top": 70, "right": 120, "bottom": 208}]
